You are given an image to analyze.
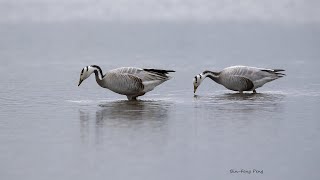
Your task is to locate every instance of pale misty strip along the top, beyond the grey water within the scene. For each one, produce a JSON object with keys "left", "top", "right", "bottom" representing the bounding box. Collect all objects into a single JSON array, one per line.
[{"left": 0, "top": 0, "right": 320, "bottom": 24}]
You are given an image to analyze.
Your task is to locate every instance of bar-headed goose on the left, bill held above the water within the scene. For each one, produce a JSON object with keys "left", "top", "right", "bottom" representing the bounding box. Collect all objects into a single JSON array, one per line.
[{"left": 78, "top": 65, "right": 175, "bottom": 100}]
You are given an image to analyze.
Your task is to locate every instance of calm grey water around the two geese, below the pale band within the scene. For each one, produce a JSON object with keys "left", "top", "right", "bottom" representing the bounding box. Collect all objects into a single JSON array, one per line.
[{"left": 0, "top": 22, "right": 320, "bottom": 180}]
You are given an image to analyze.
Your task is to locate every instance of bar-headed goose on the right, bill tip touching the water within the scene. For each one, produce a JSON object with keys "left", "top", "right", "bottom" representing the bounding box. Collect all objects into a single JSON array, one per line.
[{"left": 193, "top": 66, "right": 285, "bottom": 93}]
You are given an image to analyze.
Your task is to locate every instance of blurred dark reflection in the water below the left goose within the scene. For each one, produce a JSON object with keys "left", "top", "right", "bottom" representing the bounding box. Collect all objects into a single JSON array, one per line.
[{"left": 79, "top": 100, "right": 172, "bottom": 144}]
